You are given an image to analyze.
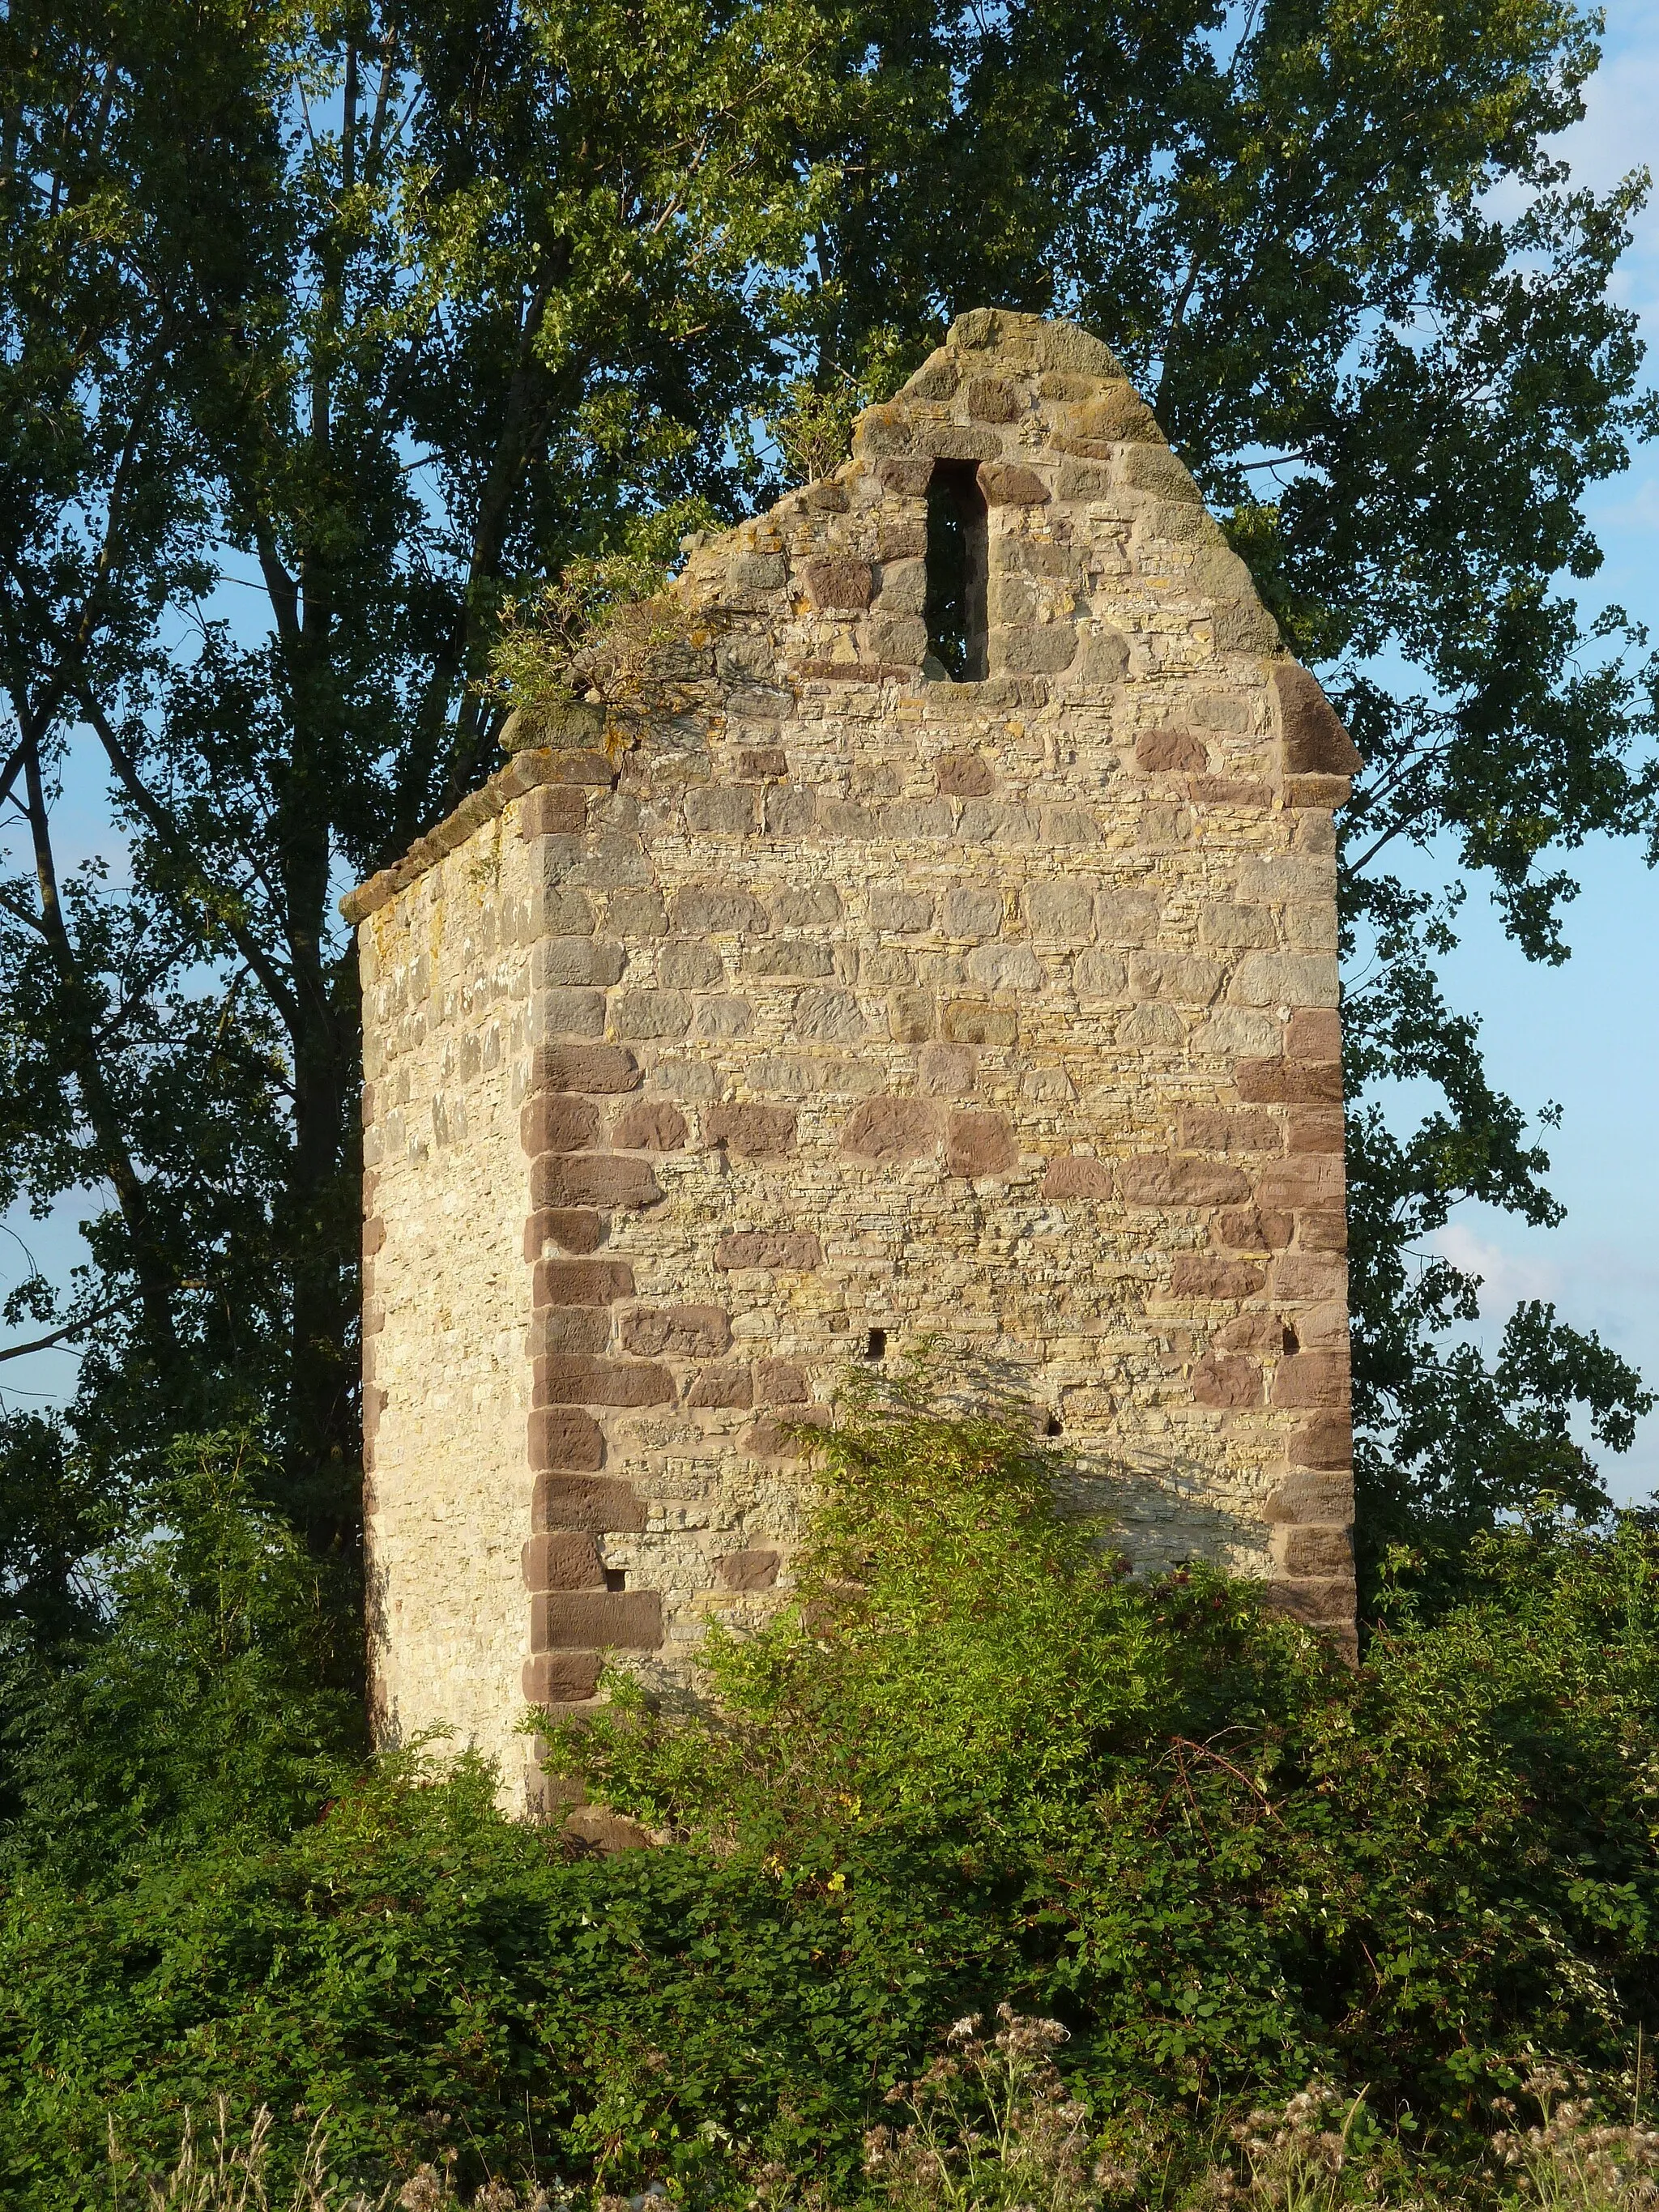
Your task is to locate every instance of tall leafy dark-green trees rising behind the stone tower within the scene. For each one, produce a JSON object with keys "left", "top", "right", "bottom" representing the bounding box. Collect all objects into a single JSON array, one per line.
[{"left": 0, "top": 0, "right": 1655, "bottom": 1645}]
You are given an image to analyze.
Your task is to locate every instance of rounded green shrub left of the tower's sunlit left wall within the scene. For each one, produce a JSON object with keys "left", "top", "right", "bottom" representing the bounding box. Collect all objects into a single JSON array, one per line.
[{"left": 0, "top": 1435, "right": 363, "bottom": 1882}]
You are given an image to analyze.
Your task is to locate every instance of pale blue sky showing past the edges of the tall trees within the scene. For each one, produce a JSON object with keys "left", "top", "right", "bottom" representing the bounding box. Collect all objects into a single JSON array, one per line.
[{"left": 0, "top": 0, "right": 1659, "bottom": 1498}]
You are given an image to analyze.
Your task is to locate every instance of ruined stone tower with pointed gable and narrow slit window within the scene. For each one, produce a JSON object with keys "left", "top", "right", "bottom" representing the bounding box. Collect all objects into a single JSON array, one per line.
[{"left": 345, "top": 309, "right": 1358, "bottom": 1803}]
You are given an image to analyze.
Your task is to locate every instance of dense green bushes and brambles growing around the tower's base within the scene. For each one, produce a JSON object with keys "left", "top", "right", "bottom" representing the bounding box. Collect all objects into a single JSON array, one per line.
[{"left": 0, "top": 1400, "right": 1659, "bottom": 2212}]
